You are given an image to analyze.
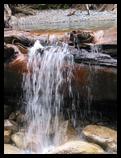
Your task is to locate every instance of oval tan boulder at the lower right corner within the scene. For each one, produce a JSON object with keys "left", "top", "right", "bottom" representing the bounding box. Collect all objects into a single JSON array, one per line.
[{"left": 82, "top": 125, "right": 117, "bottom": 152}]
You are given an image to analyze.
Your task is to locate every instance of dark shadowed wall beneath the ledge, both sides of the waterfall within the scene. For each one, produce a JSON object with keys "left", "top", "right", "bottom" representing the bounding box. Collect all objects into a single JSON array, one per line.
[{"left": 4, "top": 62, "right": 117, "bottom": 123}]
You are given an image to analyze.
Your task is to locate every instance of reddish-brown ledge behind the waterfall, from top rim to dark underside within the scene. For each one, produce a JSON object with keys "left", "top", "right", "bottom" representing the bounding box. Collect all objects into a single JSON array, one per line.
[{"left": 4, "top": 28, "right": 117, "bottom": 120}]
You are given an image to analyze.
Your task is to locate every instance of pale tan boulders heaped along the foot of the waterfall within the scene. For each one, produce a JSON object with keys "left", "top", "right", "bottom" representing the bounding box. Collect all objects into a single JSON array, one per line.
[{"left": 4, "top": 111, "right": 117, "bottom": 154}]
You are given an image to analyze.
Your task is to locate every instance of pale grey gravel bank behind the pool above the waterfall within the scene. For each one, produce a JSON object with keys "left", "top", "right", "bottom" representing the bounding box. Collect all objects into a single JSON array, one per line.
[{"left": 12, "top": 9, "right": 117, "bottom": 30}]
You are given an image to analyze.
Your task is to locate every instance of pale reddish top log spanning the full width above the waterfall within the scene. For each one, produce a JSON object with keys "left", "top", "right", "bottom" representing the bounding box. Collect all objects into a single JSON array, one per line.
[{"left": 4, "top": 28, "right": 117, "bottom": 46}]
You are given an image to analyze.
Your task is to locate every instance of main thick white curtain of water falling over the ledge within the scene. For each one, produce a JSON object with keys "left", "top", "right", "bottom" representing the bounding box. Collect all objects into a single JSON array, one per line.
[{"left": 23, "top": 41, "right": 73, "bottom": 153}]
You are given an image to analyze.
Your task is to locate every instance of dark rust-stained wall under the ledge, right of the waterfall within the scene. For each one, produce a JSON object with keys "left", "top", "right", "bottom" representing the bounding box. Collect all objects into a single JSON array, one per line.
[{"left": 62, "top": 65, "right": 117, "bottom": 123}]
